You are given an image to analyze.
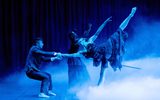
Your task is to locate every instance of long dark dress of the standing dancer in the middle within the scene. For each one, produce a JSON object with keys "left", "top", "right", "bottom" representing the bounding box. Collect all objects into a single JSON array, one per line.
[{"left": 68, "top": 33, "right": 90, "bottom": 87}]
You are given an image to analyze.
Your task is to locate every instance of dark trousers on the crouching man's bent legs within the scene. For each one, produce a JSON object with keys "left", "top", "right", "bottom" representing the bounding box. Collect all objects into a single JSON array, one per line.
[{"left": 26, "top": 70, "right": 52, "bottom": 94}]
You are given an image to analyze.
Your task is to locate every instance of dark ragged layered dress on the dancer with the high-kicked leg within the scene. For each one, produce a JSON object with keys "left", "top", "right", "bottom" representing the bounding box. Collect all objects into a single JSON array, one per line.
[{"left": 84, "top": 29, "right": 128, "bottom": 71}]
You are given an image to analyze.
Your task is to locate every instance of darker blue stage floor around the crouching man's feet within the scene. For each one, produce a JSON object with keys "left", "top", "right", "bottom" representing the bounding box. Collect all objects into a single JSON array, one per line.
[{"left": 0, "top": 73, "right": 77, "bottom": 100}]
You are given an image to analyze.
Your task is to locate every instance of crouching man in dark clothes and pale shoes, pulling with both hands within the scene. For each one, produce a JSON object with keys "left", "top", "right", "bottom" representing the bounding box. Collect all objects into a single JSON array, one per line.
[{"left": 25, "top": 38, "right": 61, "bottom": 98}]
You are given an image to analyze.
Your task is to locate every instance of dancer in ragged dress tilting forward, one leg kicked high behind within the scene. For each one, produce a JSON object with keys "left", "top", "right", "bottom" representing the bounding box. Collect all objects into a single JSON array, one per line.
[{"left": 62, "top": 7, "right": 137, "bottom": 85}]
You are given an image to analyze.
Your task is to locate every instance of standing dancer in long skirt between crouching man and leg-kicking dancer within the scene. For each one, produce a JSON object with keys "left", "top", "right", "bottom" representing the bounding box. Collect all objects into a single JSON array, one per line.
[{"left": 62, "top": 17, "right": 111, "bottom": 87}]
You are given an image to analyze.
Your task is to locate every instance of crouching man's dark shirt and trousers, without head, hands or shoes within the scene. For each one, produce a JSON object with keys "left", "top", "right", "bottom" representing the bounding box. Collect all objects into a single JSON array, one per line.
[{"left": 25, "top": 46, "right": 54, "bottom": 93}]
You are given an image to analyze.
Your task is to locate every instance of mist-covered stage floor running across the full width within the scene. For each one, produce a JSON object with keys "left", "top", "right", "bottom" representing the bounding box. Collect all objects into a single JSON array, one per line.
[{"left": 0, "top": 58, "right": 160, "bottom": 100}]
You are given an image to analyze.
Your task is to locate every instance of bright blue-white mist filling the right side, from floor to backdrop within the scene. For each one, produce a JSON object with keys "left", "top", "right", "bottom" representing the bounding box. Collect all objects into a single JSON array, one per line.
[{"left": 77, "top": 17, "right": 160, "bottom": 100}]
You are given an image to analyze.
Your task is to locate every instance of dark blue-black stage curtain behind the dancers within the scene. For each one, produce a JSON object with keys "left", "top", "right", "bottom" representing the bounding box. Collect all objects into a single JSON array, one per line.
[{"left": 0, "top": 0, "right": 160, "bottom": 78}]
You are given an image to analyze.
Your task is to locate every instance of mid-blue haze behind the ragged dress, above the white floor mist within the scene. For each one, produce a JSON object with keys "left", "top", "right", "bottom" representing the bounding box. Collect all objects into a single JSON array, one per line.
[{"left": 125, "top": 17, "right": 160, "bottom": 59}]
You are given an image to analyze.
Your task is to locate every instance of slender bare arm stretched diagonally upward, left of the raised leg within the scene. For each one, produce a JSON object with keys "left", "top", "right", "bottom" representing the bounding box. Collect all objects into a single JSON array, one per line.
[{"left": 89, "top": 17, "right": 112, "bottom": 42}]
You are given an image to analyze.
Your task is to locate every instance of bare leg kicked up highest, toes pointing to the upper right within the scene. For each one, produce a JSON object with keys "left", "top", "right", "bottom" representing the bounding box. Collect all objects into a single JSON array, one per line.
[{"left": 119, "top": 7, "right": 137, "bottom": 30}]
